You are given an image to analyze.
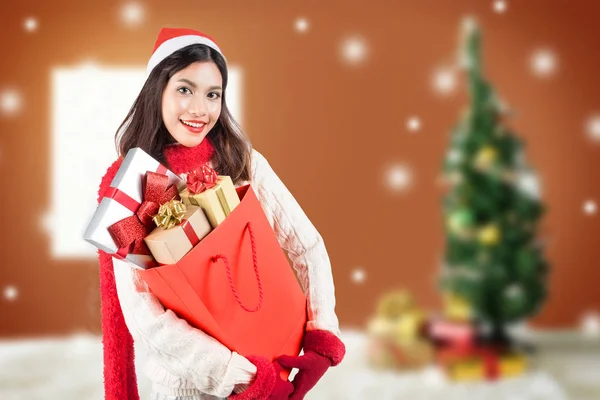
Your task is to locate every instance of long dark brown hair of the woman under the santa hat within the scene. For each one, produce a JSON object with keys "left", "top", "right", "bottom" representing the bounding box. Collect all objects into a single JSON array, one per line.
[{"left": 115, "top": 44, "right": 251, "bottom": 183}]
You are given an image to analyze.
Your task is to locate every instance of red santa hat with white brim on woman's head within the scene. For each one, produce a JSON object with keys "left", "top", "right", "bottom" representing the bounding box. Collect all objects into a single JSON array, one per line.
[{"left": 146, "top": 28, "right": 225, "bottom": 75}]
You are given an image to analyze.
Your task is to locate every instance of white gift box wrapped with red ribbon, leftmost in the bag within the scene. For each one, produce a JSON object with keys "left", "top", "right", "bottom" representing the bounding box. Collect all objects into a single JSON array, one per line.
[{"left": 83, "top": 147, "right": 185, "bottom": 268}]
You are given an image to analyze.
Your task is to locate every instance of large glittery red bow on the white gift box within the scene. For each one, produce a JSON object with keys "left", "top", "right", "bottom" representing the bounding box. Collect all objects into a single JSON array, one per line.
[{"left": 108, "top": 171, "right": 179, "bottom": 255}]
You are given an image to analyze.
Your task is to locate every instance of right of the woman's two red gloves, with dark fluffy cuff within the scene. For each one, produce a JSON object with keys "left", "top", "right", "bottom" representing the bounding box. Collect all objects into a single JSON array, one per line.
[{"left": 277, "top": 330, "right": 346, "bottom": 400}]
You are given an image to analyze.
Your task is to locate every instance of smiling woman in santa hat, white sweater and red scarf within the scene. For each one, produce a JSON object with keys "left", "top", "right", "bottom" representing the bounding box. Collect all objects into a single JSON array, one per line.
[{"left": 99, "top": 28, "right": 345, "bottom": 400}]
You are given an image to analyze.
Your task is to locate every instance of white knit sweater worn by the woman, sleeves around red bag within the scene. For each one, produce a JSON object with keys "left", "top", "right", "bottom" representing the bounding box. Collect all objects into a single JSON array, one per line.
[{"left": 113, "top": 150, "right": 340, "bottom": 399}]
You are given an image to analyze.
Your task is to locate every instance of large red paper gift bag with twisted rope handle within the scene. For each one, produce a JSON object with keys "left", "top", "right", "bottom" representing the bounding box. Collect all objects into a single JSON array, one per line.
[{"left": 138, "top": 185, "right": 307, "bottom": 376}]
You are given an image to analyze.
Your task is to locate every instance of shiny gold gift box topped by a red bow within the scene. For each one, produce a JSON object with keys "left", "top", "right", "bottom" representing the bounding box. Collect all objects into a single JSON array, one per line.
[{"left": 179, "top": 175, "right": 240, "bottom": 228}]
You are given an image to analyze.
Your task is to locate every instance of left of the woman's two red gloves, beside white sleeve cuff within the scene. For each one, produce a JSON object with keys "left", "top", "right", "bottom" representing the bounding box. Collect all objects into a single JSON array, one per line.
[{"left": 228, "top": 356, "right": 294, "bottom": 400}]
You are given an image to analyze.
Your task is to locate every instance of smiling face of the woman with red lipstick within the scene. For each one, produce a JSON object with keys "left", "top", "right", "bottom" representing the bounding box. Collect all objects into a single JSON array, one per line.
[{"left": 162, "top": 62, "right": 223, "bottom": 147}]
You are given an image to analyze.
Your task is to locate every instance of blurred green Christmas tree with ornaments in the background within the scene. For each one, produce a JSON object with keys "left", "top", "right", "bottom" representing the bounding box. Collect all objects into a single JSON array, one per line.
[{"left": 441, "top": 19, "right": 548, "bottom": 341}]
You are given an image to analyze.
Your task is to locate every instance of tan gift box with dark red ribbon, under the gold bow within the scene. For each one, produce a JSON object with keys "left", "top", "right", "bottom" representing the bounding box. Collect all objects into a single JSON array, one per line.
[{"left": 144, "top": 206, "right": 212, "bottom": 264}]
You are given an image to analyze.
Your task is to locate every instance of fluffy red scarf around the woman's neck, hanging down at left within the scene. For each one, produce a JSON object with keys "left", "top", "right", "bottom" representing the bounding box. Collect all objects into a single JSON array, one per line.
[{"left": 98, "top": 140, "right": 215, "bottom": 400}]
